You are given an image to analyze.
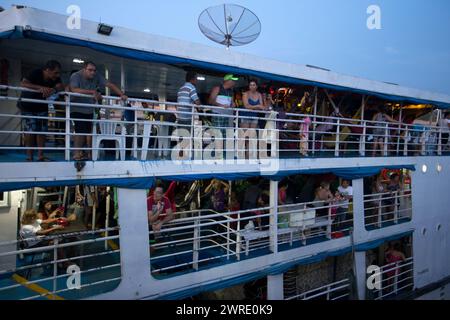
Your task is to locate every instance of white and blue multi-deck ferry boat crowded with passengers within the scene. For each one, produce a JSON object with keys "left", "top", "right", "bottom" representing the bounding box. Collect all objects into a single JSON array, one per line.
[{"left": 0, "top": 6, "right": 450, "bottom": 300}]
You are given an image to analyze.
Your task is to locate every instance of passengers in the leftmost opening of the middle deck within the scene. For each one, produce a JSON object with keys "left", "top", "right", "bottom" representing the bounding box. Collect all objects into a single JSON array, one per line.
[{"left": 19, "top": 185, "right": 118, "bottom": 273}]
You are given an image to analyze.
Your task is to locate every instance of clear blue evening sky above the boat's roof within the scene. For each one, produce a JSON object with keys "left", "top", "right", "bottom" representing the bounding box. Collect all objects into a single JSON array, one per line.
[{"left": 0, "top": 0, "right": 450, "bottom": 94}]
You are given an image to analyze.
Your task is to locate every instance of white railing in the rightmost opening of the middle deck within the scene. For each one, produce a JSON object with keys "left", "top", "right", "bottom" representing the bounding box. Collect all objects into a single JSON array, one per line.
[{"left": 364, "top": 191, "right": 412, "bottom": 228}]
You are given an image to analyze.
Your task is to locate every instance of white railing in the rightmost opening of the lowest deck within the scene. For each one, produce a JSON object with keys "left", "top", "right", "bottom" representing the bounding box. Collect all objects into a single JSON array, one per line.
[{"left": 372, "top": 257, "right": 414, "bottom": 300}]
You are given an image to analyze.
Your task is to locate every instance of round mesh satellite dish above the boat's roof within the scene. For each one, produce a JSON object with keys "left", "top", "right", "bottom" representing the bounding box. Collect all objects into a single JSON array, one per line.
[{"left": 198, "top": 4, "right": 261, "bottom": 49}]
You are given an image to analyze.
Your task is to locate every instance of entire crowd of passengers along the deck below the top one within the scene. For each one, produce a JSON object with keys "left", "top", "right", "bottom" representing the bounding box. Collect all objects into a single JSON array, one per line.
[{"left": 19, "top": 172, "right": 410, "bottom": 262}]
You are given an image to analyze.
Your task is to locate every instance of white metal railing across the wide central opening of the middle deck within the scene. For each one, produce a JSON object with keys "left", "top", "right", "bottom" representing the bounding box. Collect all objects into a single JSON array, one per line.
[{"left": 149, "top": 201, "right": 353, "bottom": 275}]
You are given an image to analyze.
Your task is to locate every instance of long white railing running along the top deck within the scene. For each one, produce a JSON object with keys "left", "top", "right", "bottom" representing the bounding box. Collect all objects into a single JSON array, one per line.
[{"left": 0, "top": 85, "right": 446, "bottom": 161}]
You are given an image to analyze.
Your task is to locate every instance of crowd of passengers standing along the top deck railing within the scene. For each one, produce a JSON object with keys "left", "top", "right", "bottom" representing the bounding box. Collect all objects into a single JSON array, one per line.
[{"left": 18, "top": 60, "right": 450, "bottom": 161}]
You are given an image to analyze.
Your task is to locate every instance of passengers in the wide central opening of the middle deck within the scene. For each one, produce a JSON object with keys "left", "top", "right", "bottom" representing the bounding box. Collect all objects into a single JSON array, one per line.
[{"left": 147, "top": 175, "right": 353, "bottom": 234}]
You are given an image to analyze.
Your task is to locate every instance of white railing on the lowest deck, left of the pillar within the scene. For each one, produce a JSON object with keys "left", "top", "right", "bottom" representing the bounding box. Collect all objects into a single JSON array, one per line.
[{"left": 285, "top": 279, "right": 350, "bottom": 300}]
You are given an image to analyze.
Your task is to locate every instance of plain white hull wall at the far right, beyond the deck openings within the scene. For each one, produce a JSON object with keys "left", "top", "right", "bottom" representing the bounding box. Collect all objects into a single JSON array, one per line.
[{"left": 412, "top": 157, "right": 450, "bottom": 288}]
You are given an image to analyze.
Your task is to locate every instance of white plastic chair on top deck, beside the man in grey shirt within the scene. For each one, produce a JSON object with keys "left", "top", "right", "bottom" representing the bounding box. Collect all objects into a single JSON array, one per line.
[{"left": 92, "top": 121, "right": 126, "bottom": 161}]
